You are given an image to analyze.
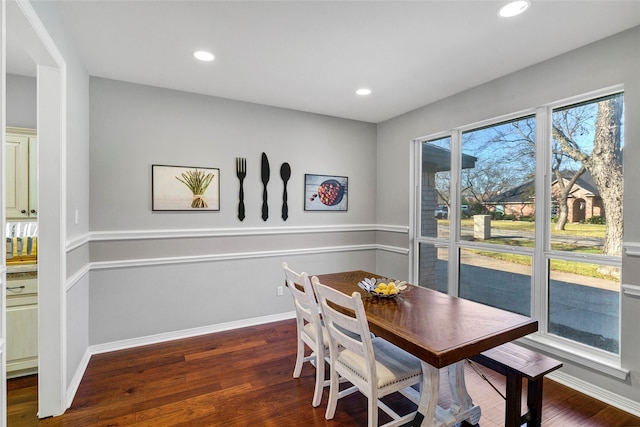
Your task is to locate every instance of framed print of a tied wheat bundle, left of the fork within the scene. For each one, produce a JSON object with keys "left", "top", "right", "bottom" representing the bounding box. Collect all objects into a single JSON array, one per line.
[{"left": 151, "top": 165, "right": 220, "bottom": 212}]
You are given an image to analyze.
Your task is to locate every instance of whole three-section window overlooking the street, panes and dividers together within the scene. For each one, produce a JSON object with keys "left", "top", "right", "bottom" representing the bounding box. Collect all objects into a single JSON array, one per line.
[{"left": 415, "top": 88, "right": 624, "bottom": 354}]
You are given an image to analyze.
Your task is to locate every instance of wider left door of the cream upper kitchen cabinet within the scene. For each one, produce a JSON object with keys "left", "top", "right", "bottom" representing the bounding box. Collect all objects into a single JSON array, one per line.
[{"left": 5, "top": 134, "right": 29, "bottom": 219}]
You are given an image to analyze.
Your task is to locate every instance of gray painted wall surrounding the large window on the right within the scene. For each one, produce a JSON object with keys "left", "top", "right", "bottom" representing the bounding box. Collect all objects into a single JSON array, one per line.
[{"left": 376, "top": 27, "right": 640, "bottom": 408}]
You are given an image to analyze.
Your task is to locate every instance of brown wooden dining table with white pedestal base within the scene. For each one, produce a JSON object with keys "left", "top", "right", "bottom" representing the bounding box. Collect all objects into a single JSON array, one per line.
[{"left": 317, "top": 270, "right": 538, "bottom": 427}]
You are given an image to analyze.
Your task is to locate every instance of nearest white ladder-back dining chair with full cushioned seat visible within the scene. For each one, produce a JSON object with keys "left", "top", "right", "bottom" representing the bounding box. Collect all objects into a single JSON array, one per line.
[{"left": 311, "top": 276, "right": 427, "bottom": 427}]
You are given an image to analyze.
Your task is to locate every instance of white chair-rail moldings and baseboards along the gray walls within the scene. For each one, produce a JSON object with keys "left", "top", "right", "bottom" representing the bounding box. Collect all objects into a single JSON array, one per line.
[{"left": 61, "top": 231, "right": 640, "bottom": 416}]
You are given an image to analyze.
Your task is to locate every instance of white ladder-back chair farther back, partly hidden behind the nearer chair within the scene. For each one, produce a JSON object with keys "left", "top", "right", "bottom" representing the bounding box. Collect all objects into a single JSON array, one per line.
[{"left": 282, "top": 262, "right": 329, "bottom": 407}]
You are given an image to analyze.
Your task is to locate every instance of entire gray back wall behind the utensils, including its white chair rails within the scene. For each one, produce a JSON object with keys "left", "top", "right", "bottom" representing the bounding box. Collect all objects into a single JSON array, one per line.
[{"left": 89, "top": 77, "right": 376, "bottom": 344}]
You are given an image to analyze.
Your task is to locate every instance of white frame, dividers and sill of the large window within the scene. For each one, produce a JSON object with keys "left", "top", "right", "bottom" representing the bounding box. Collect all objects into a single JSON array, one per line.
[{"left": 409, "top": 85, "right": 629, "bottom": 379}]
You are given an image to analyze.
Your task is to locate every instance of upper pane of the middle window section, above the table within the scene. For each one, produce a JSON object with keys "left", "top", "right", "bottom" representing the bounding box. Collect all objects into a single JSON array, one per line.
[{"left": 460, "top": 116, "right": 536, "bottom": 244}]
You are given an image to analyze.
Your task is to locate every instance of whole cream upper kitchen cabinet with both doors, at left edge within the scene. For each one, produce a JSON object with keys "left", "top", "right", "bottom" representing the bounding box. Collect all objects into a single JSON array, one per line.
[{"left": 5, "top": 127, "right": 38, "bottom": 219}]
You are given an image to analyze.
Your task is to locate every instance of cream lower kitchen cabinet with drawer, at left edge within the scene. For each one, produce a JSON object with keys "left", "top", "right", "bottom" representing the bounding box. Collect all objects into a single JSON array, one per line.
[{"left": 6, "top": 275, "right": 38, "bottom": 377}]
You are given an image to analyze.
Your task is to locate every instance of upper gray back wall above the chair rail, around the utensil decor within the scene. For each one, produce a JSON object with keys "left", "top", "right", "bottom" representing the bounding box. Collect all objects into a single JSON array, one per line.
[{"left": 91, "top": 78, "right": 376, "bottom": 231}]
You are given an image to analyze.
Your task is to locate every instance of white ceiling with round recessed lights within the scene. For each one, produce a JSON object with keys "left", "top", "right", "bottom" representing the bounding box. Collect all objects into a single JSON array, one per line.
[{"left": 7, "top": 0, "right": 640, "bottom": 123}]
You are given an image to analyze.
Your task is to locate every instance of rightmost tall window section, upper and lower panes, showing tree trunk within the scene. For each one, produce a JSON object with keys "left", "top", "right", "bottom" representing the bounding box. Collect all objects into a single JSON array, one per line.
[{"left": 547, "top": 93, "right": 624, "bottom": 353}]
